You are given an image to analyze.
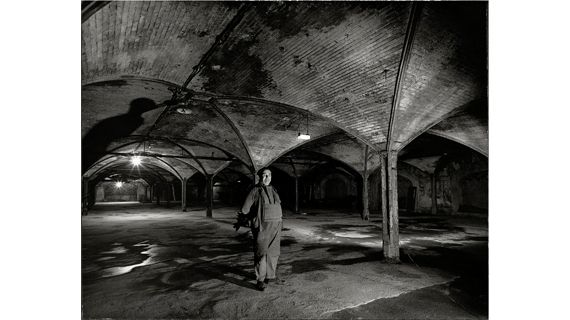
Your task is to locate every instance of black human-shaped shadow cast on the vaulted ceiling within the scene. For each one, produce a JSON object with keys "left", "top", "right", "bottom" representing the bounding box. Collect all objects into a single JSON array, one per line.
[{"left": 81, "top": 98, "right": 159, "bottom": 173}]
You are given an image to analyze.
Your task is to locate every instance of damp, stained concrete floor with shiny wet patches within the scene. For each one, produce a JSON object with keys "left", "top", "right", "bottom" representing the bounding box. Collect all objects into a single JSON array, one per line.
[{"left": 82, "top": 203, "right": 488, "bottom": 319}]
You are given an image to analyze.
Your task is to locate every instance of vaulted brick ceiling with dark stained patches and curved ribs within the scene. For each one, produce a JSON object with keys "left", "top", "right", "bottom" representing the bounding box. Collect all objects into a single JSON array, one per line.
[{"left": 81, "top": 1, "right": 488, "bottom": 181}]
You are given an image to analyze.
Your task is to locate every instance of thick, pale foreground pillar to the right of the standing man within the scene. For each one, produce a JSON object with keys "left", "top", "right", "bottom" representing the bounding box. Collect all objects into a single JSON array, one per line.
[{"left": 381, "top": 152, "right": 400, "bottom": 263}]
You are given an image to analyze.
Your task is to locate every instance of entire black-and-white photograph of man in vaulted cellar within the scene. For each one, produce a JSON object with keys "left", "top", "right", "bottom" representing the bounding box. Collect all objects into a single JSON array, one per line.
[{"left": 81, "top": 1, "right": 489, "bottom": 319}]
